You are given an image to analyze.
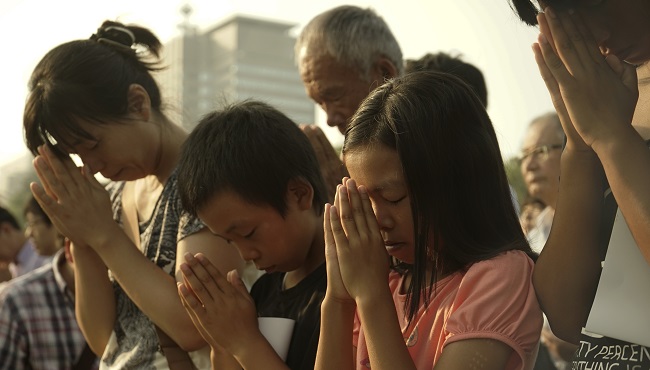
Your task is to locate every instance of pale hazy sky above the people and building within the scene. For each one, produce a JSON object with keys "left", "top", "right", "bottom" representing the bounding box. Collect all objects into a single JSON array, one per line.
[{"left": 0, "top": 0, "right": 552, "bottom": 169}]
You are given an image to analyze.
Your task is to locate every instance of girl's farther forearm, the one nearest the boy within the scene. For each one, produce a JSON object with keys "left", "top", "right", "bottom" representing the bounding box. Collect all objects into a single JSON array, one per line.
[{"left": 314, "top": 296, "right": 356, "bottom": 370}]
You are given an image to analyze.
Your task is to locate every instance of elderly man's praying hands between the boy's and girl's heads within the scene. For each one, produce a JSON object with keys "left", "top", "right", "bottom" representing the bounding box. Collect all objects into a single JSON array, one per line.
[{"left": 300, "top": 125, "right": 348, "bottom": 201}]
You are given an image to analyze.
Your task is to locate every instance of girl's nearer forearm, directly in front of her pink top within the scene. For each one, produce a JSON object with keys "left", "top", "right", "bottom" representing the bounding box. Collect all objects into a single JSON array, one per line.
[{"left": 357, "top": 287, "right": 416, "bottom": 370}]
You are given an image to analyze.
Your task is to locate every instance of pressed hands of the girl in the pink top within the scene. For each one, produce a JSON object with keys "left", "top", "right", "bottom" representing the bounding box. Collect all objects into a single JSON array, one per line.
[{"left": 325, "top": 178, "right": 389, "bottom": 305}]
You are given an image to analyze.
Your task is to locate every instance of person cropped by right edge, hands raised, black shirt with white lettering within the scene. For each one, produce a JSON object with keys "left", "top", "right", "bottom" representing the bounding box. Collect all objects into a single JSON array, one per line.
[{"left": 511, "top": 0, "right": 650, "bottom": 369}]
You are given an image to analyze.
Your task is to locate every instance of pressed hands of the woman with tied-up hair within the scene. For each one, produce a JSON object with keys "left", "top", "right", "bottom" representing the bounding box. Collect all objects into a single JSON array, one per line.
[{"left": 30, "top": 146, "right": 122, "bottom": 248}]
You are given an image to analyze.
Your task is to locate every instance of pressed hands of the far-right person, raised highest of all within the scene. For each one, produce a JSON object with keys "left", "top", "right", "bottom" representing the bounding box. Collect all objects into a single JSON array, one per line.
[{"left": 533, "top": 8, "right": 638, "bottom": 149}]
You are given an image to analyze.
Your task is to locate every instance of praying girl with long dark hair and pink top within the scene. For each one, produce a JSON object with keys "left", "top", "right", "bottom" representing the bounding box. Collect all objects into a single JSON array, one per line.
[{"left": 316, "top": 72, "right": 542, "bottom": 369}]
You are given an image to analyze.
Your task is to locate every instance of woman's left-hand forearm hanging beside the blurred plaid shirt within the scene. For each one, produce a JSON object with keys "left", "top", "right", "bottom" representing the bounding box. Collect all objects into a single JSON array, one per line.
[{"left": 72, "top": 247, "right": 115, "bottom": 356}]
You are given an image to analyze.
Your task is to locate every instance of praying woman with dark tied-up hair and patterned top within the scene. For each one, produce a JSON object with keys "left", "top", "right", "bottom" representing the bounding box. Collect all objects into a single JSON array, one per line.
[{"left": 24, "top": 21, "right": 241, "bottom": 369}]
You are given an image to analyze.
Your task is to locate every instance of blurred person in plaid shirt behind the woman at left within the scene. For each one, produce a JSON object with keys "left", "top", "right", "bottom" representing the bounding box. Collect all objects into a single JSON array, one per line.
[{"left": 0, "top": 198, "right": 98, "bottom": 370}]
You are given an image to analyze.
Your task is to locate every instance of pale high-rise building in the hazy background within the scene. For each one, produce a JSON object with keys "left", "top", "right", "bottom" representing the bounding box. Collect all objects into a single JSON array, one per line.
[{"left": 157, "top": 10, "right": 315, "bottom": 130}]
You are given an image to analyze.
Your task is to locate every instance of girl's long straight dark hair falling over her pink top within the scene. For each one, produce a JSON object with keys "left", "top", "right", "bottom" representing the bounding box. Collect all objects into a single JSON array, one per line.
[{"left": 343, "top": 72, "right": 534, "bottom": 321}]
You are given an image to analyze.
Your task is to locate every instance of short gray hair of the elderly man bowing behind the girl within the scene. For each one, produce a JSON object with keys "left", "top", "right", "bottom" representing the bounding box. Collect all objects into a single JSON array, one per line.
[{"left": 295, "top": 5, "right": 404, "bottom": 79}]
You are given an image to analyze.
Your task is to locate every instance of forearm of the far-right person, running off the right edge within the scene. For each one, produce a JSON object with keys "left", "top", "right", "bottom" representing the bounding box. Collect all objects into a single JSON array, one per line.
[{"left": 594, "top": 127, "right": 650, "bottom": 265}]
